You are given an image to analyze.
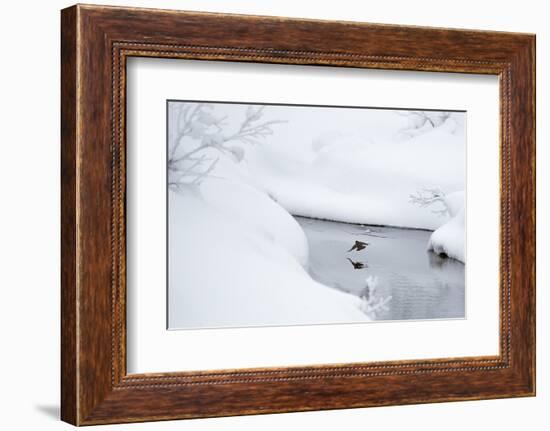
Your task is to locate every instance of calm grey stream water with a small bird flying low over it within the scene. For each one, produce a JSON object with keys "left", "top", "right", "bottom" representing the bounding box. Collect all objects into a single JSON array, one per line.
[{"left": 296, "top": 217, "right": 465, "bottom": 320}]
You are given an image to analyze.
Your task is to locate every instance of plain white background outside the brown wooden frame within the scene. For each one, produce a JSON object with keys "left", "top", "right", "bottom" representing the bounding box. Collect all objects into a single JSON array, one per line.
[{"left": 0, "top": 0, "right": 550, "bottom": 431}]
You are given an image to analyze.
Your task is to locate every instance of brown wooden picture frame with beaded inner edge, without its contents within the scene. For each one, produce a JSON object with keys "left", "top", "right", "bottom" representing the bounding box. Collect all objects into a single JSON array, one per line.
[{"left": 61, "top": 5, "right": 535, "bottom": 425}]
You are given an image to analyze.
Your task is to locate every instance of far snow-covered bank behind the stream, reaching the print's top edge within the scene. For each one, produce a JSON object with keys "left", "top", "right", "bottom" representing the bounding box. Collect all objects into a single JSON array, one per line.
[{"left": 170, "top": 104, "right": 466, "bottom": 230}]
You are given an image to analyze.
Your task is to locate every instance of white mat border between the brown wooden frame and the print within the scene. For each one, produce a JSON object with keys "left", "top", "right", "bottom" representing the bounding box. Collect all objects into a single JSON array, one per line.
[{"left": 127, "top": 58, "right": 499, "bottom": 373}]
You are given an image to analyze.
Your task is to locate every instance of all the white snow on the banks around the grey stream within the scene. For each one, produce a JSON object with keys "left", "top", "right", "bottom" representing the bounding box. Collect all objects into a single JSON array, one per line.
[{"left": 169, "top": 104, "right": 466, "bottom": 328}]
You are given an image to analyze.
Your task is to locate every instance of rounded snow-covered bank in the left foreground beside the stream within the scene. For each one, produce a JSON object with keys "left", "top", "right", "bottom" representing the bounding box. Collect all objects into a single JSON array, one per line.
[{"left": 169, "top": 179, "right": 369, "bottom": 328}]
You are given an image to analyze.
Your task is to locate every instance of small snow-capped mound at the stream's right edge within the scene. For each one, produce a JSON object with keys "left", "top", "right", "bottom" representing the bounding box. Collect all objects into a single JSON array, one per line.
[{"left": 428, "top": 192, "right": 466, "bottom": 263}]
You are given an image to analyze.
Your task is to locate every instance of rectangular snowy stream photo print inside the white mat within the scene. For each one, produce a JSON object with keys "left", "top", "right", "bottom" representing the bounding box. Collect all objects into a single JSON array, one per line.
[{"left": 167, "top": 100, "right": 466, "bottom": 329}]
